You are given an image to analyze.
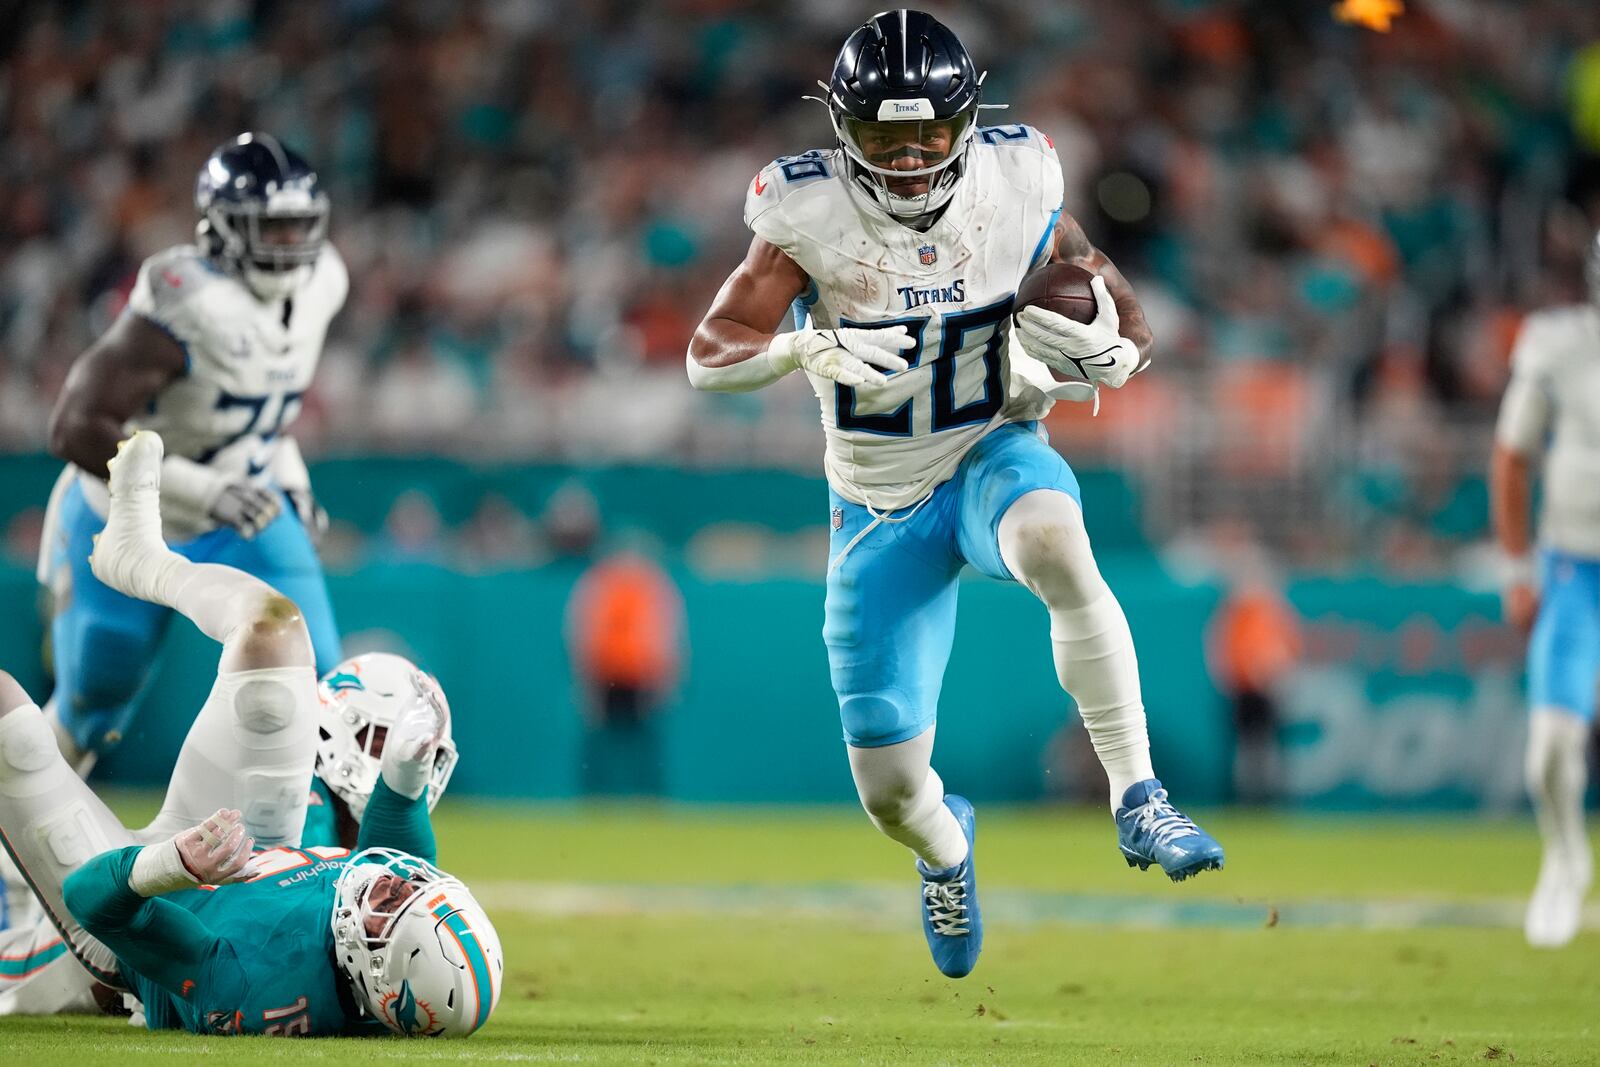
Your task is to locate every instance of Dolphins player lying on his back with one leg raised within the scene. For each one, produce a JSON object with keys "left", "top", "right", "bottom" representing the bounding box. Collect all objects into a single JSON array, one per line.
[{"left": 0, "top": 432, "right": 504, "bottom": 1037}]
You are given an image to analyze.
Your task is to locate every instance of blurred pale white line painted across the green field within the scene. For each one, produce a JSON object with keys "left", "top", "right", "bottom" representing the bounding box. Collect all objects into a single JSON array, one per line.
[{"left": 472, "top": 881, "right": 1600, "bottom": 929}]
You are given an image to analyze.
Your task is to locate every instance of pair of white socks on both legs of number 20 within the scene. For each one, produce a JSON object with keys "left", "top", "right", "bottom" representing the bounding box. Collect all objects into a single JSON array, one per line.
[{"left": 846, "top": 490, "right": 1155, "bottom": 870}]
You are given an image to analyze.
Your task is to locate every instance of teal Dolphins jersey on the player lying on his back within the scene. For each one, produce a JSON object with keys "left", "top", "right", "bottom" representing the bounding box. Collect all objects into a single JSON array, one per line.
[{"left": 64, "top": 781, "right": 437, "bottom": 1035}]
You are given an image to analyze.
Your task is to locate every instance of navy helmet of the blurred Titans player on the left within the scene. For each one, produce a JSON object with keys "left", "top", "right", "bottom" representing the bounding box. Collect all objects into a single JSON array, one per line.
[{"left": 195, "top": 133, "right": 328, "bottom": 299}]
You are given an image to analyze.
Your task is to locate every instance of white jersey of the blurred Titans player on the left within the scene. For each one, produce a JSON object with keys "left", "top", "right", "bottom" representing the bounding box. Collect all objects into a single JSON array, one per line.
[{"left": 80, "top": 245, "right": 350, "bottom": 537}]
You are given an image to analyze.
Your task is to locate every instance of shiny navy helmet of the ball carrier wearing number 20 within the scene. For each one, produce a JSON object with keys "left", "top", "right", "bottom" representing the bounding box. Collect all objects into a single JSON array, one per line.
[{"left": 822, "top": 8, "right": 982, "bottom": 218}]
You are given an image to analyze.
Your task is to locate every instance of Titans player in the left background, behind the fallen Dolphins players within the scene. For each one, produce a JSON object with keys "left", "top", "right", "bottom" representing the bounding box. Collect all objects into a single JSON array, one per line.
[{"left": 38, "top": 133, "right": 349, "bottom": 771}]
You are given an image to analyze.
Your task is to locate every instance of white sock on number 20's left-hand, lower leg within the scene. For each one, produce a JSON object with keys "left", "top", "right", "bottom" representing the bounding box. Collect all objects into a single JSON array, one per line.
[{"left": 846, "top": 728, "right": 966, "bottom": 870}]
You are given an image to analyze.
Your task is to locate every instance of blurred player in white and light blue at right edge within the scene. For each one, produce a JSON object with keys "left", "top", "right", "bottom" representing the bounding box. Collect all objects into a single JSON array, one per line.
[{"left": 1490, "top": 235, "right": 1600, "bottom": 949}]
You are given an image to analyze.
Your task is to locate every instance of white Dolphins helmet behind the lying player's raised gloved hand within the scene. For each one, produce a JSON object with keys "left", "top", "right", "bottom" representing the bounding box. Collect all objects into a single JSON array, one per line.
[{"left": 317, "top": 653, "right": 456, "bottom": 822}]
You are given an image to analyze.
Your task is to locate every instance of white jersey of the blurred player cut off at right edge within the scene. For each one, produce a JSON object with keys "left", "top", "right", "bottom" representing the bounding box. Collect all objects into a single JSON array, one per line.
[{"left": 1494, "top": 304, "right": 1600, "bottom": 560}]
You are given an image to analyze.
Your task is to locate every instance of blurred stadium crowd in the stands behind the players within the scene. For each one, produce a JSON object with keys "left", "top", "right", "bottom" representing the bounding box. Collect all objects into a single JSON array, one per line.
[{"left": 0, "top": 0, "right": 1600, "bottom": 571}]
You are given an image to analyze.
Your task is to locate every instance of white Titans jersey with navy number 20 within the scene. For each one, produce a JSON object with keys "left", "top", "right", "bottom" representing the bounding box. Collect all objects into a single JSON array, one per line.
[{"left": 744, "top": 125, "right": 1062, "bottom": 509}]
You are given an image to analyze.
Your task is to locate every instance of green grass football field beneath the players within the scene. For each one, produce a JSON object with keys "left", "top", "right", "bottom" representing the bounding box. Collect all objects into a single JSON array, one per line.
[{"left": 0, "top": 798, "right": 1600, "bottom": 1065}]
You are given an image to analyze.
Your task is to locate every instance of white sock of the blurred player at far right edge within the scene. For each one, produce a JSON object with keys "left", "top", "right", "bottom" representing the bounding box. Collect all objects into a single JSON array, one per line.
[{"left": 1525, "top": 707, "right": 1594, "bottom": 886}]
